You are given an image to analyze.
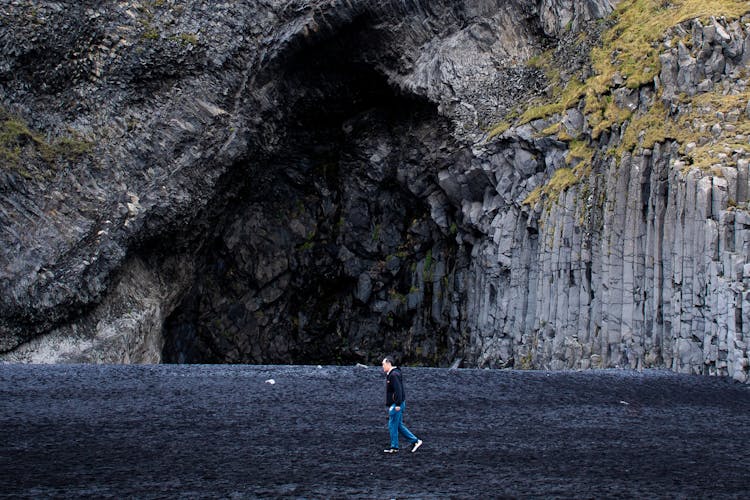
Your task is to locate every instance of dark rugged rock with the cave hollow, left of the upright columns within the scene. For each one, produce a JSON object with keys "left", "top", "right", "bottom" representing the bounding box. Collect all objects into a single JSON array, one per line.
[{"left": 0, "top": 0, "right": 552, "bottom": 364}]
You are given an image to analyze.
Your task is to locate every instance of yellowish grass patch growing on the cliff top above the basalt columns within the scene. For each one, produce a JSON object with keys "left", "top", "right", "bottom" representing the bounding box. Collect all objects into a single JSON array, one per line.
[{"left": 496, "top": 0, "right": 750, "bottom": 205}]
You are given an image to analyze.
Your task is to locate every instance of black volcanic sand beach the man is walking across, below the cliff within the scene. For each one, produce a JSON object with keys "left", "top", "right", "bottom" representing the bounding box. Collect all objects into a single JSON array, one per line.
[{"left": 0, "top": 365, "right": 750, "bottom": 498}]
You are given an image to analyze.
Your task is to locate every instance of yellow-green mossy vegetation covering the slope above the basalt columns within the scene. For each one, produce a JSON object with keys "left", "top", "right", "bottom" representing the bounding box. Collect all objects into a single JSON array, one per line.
[{"left": 500, "top": 0, "right": 750, "bottom": 204}]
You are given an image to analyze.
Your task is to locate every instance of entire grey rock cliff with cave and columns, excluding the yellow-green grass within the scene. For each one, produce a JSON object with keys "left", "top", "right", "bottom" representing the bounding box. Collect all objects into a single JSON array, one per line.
[{"left": 0, "top": 0, "right": 750, "bottom": 380}]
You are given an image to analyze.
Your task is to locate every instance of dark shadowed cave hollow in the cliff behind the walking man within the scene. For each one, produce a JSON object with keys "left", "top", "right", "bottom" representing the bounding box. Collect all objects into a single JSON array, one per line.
[{"left": 163, "top": 16, "right": 458, "bottom": 364}]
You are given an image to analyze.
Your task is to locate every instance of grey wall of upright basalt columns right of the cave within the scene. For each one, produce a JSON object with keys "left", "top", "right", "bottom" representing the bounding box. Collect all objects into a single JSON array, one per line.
[{"left": 467, "top": 15, "right": 750, "bottom": 381}]
